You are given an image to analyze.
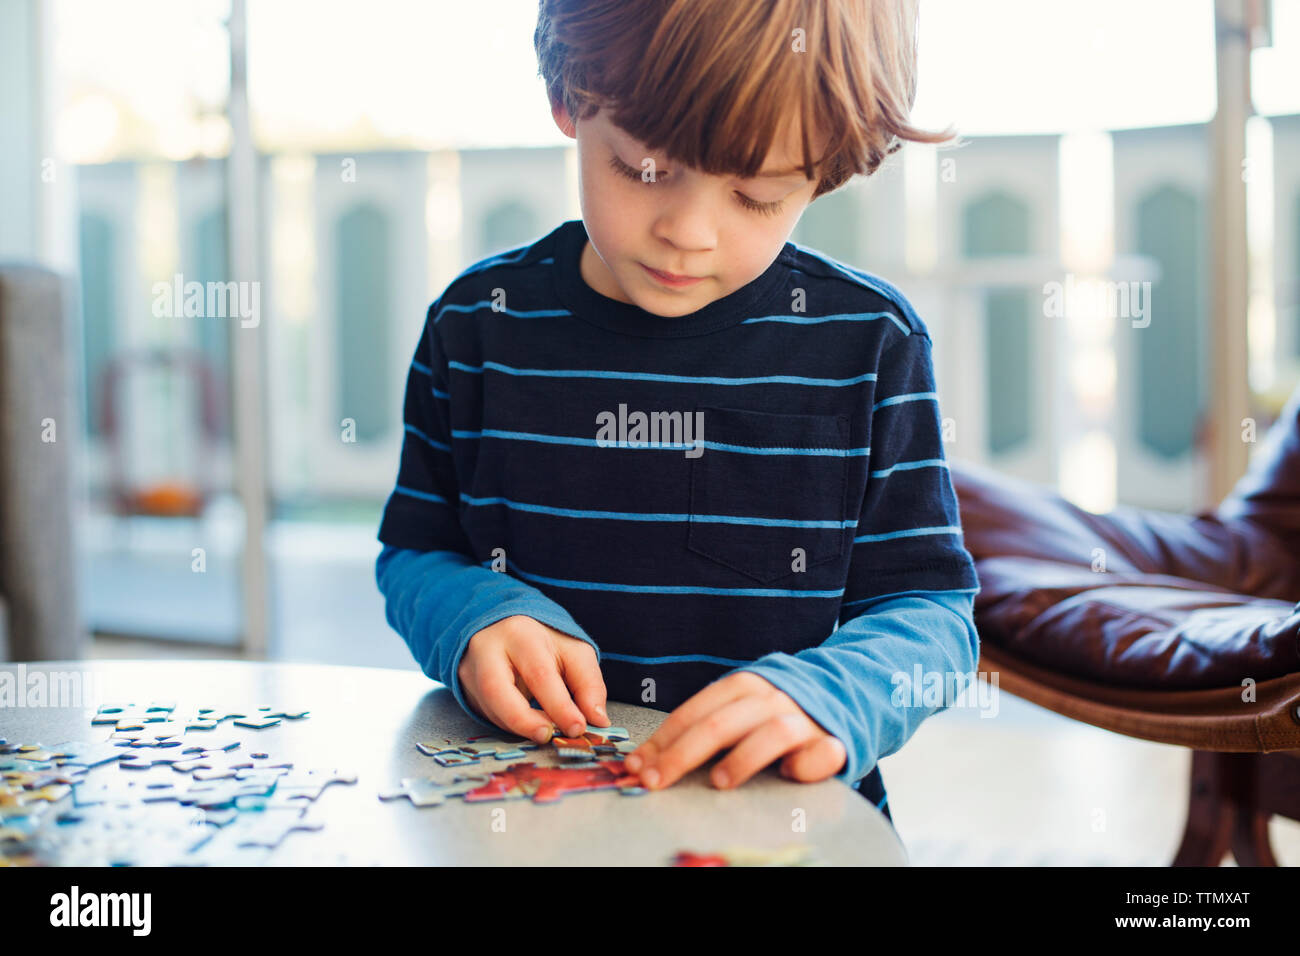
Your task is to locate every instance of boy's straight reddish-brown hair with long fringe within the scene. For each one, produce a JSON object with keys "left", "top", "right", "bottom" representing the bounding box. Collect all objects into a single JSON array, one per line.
[{"left": 533, "top": 0, "right": 953, "bottom": 199}]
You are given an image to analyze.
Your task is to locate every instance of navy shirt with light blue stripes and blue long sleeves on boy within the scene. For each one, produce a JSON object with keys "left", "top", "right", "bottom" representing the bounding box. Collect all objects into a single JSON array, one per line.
[{"left": 377, "top": 220, "right": 979, "bottom": 809}]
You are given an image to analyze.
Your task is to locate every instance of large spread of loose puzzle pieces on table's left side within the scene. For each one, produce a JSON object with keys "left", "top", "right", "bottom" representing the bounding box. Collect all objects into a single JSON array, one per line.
[{"left": 0, "top": 702, "right": 335, "bottom": 866}]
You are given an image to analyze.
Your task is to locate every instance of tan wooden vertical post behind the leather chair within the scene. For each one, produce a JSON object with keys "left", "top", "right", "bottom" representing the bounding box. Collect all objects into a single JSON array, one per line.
[{"left": 1205, "top": 0, "right": 1252, "bottom": 505}]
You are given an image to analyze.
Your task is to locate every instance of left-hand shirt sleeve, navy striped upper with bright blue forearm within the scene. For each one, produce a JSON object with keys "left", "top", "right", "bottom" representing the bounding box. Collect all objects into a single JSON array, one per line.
[{"left": 374, "top": 299, "right": 599, "bottom": 715}]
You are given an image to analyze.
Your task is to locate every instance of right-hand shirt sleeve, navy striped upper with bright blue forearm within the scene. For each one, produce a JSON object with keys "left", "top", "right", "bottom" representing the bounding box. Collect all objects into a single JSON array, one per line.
[{"left": 740, "top": 332, "right": 979, "bottom": 783}]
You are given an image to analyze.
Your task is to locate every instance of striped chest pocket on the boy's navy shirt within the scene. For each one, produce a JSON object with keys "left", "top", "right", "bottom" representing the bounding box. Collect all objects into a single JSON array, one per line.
[{"left": 686, "top": 406, "right": 849, "bottom": 584}]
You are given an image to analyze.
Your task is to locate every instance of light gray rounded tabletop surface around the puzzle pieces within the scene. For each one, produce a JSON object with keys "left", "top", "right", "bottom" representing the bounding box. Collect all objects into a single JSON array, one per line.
[{"left": 0, "top": 661, "right": 906, "bottom": 866}]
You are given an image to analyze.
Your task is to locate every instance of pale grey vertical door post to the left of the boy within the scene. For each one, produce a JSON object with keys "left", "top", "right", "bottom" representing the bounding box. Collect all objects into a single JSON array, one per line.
[{"left": 226, "top": 0, "right": 270, "bottom": 657}]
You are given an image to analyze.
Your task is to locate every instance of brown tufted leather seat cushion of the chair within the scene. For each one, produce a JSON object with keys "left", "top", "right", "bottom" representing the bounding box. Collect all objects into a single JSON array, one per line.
[{"left": 950, "top": 463, "right": 1300, "bottom": 691}]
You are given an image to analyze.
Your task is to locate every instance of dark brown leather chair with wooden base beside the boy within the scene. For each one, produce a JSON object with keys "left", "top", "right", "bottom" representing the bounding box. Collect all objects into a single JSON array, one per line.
[{"left": 950, "top": 389, "right": 1300, "bottom": 866}]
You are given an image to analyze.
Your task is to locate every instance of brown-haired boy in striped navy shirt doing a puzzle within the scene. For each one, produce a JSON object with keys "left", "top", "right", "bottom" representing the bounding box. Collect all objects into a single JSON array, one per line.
[{"left": 376, "top": 0, "right": 978, "bottom": 817}]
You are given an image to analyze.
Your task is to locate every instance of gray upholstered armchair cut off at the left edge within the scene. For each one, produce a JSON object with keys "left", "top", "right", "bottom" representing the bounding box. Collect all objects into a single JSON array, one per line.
[{"left": 0, "top": 264, "right": 86, "bottom": 661}]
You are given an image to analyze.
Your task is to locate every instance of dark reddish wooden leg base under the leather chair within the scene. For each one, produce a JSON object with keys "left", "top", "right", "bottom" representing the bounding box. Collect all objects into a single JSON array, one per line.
[{"left": 1173, "top": 750, "right": 1278, "bottom": 866}]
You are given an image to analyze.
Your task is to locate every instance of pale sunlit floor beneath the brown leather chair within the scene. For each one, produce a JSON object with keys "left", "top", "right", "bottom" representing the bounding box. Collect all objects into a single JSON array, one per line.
[{"left": 880, "top": 693, "right": 1300, "bottom": 866}]
